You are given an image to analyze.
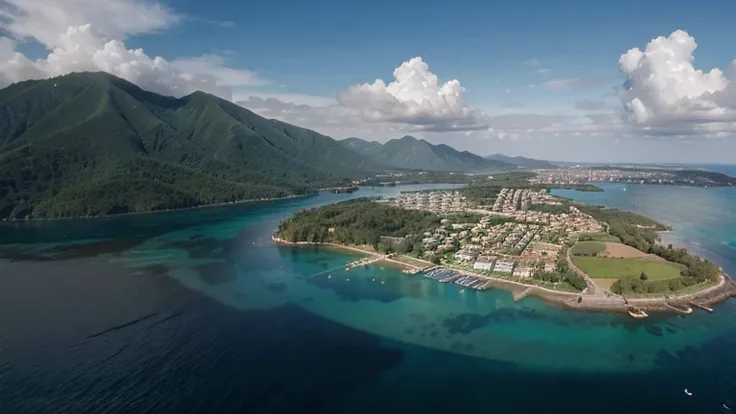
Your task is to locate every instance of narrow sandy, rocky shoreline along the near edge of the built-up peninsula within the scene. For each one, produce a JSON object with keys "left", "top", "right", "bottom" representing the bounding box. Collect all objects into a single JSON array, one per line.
[{"left": 271, "top": 235, "right": 736, "bottom": 314}]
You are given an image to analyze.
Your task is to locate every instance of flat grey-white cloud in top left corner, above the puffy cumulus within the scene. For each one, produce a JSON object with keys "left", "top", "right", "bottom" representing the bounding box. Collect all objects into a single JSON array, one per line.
[{"left": 0, "top": 0, "right": 181, "bottom": 48}]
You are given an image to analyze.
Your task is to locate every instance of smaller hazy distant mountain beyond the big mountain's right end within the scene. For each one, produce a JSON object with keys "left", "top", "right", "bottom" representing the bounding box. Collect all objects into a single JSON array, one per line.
[{"left": 340, "top": 135, "right": 516, "bottom": 172}]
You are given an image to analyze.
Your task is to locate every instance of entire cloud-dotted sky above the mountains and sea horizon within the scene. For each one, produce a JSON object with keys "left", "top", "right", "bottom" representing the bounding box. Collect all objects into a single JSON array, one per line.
[{"left": 0, "top": 0, "right": 736, "bottom": 162}]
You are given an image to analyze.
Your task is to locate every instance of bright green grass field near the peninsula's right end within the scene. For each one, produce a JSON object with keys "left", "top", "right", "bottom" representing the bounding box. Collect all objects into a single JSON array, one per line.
[{"left": 572, "top": 256, "right": 680, "bottom": 281}]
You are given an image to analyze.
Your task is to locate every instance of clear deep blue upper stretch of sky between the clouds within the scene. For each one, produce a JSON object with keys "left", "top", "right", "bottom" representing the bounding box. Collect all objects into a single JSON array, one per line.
[{"left": 129, "top": 0, "right": 736, "bottom": 105}]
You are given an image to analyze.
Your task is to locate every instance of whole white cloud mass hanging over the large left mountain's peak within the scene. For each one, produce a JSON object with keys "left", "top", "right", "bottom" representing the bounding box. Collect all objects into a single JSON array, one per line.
[{"left": 0, "top": 0, "right": 267, "bottom": 99}]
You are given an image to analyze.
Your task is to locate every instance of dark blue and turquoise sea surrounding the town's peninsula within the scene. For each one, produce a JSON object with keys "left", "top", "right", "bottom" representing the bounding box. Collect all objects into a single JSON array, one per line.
[{"left": 0, "top": 184, "right": 736, "bottom": 414}]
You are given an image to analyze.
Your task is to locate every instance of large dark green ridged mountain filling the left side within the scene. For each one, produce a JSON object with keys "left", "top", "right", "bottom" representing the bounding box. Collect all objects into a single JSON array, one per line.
[{"left": 0, "top": 72, "right": 382, "bottom": 218}]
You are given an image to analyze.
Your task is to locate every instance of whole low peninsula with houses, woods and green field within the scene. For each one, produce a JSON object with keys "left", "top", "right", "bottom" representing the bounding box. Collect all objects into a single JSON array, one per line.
[{"left": 273, "top": 180, "right": 736, "bottom": 318}]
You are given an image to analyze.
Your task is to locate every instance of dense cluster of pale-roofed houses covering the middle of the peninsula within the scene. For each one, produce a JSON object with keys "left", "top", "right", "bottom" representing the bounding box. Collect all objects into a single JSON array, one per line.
[{"left": 388, "top": 188, "right": 604, "bottom": 284}]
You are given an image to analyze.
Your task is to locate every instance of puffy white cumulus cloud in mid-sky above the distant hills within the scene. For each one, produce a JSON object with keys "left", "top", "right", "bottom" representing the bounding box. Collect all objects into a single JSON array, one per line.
[{"left": 337, "top": 57, "right": 488, "bottom": 131}]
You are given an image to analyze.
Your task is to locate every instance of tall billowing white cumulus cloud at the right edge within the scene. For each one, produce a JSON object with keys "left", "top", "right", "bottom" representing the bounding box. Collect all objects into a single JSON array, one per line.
[{"left": 619, "top": 30, "right": 736, "bottom": 124}]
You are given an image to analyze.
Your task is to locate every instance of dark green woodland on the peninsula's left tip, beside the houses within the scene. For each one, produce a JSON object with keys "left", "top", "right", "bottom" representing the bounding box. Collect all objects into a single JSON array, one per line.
[{"left": 277, "top": 198, "right": 440, "bottom": 253}]
